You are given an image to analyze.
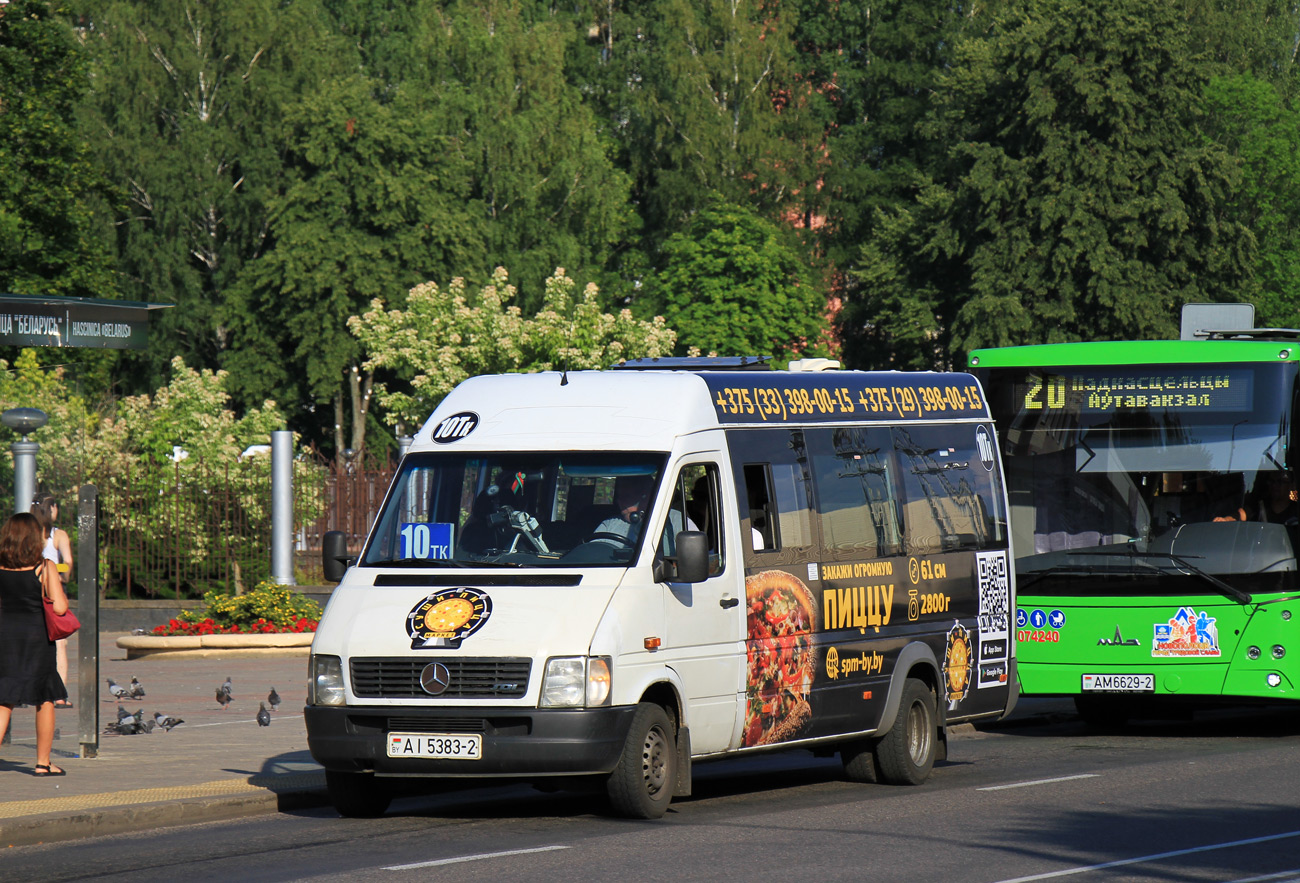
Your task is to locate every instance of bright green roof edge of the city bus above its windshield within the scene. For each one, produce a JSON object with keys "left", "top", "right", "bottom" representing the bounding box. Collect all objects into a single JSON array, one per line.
[{"left": 970, "top": 339, "right": 1300, "bottom": 368}]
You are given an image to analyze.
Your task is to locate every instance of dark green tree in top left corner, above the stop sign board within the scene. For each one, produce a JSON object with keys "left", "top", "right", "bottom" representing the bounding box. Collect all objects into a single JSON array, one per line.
[{"left": 0, "top": 0, "right": 117, "bottom": 298}]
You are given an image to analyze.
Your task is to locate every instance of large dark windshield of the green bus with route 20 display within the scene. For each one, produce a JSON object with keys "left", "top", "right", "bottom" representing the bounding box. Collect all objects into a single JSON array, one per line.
[{"left": 982, "top": 364, "right": 1297, "bottom": 594}]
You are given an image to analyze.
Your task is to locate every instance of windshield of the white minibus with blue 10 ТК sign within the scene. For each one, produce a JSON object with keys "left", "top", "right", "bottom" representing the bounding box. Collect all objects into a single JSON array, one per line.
[{"left": 360, "top": 453, "right": 667, "bottom": 567}]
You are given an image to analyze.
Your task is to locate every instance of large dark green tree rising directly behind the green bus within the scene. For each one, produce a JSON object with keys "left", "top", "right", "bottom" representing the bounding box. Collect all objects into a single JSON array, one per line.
[{"left": 845, "top": 0, "right": 1253, "bottom": 367}]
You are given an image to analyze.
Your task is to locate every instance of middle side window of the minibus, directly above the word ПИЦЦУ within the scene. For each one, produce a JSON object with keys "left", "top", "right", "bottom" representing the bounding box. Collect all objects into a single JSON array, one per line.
[{"left": 809, "top": 427, "right": 902, "bottom": 560}]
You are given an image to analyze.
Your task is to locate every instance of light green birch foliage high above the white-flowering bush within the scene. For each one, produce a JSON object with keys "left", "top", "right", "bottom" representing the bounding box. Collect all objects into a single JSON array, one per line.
[{"left": 426, "top": 0, "right": 636, "bottom": 310}]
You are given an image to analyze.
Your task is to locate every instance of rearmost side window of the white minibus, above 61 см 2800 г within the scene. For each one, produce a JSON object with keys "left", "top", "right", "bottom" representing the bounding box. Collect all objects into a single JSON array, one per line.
[{"left": 892, "top": 424, "right": 1006, "bottom": 555}]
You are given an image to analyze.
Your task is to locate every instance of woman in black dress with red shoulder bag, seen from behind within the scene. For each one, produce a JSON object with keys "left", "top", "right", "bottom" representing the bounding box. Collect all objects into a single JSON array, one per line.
[{"left": 0, "top": 512, "right": 68, "bottom": 776}]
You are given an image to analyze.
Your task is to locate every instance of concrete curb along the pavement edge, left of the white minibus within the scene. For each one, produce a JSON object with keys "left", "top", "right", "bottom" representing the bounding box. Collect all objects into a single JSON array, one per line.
[{"left": 0, "top": 770, "right": 330, "bottom": 848}]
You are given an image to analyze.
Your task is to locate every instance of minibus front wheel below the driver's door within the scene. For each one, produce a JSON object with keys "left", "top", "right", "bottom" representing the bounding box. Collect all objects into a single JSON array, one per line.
[{"left": 606, "top": 702, "right": 677, "bottom": 819}]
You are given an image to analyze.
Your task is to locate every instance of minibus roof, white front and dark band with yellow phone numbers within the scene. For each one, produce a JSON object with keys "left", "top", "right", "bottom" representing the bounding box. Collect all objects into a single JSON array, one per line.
[{"left": 412, "top": 371, "right": 988, "bottom": 451}]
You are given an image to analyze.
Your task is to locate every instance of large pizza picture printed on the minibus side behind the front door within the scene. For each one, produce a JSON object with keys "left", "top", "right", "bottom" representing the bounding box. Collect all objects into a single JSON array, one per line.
[{"left": 742, "top": 571, "right": 816, "bottom": 746}]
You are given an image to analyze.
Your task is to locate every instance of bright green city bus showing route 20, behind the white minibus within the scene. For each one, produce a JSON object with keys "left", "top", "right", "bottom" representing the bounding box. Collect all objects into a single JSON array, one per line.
[{"left": 970, "top": 313, "right": 1300, "bottom": 724}]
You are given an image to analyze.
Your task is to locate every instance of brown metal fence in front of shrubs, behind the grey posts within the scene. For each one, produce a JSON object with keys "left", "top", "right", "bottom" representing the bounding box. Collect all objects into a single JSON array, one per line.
[{"left": 38, "top": 456, "right": 397, "bottom": 600}]
